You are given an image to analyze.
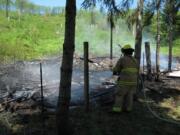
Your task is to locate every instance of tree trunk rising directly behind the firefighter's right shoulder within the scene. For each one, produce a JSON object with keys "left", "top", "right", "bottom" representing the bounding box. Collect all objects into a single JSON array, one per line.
[{"left": 135, "top": 0, "right": 144, "bottom": 69}]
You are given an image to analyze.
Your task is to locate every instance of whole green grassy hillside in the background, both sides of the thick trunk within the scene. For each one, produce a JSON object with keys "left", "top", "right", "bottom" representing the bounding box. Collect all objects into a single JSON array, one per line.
[{"left": 0, "top": 10, "right": 180, "bottom": 62}]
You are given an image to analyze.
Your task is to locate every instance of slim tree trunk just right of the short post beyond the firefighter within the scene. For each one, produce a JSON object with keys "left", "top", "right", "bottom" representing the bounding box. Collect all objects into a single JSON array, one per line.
[{"left": 156, "top": 0, "right": 160, "bottom": 80}]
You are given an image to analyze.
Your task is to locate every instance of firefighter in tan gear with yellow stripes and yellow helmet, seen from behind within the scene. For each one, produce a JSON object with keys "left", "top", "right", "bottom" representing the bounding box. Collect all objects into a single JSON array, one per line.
[{"left": 112, "top": 44, "right": 138, "bottom": 113}]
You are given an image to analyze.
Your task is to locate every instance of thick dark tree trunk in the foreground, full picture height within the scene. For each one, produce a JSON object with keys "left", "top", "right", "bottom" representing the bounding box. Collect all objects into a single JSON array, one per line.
[{"left": 56, "top": 0, "right": 76, "bottom": 135}]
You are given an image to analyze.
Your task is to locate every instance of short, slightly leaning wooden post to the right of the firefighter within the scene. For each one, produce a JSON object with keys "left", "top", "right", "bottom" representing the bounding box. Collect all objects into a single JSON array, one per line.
[{"left": 145, "top": 42, "right": 152, "bottom": 80}]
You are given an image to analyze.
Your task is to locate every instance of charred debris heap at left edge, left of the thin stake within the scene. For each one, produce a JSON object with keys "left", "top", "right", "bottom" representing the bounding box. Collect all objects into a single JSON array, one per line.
[{"left": 0, "top": 92, "right": 41, "bottom": 114}]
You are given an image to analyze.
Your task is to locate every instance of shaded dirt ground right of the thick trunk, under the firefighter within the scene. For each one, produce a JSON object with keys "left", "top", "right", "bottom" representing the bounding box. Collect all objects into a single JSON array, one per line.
[{"left": 71, "top": 78, "right": 180, "bottom": 135}]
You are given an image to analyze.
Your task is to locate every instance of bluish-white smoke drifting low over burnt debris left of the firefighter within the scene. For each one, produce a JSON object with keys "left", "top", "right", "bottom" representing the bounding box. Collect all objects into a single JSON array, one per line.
[{"left": 0, "top": 58, "right": 112, "bottom": 105}]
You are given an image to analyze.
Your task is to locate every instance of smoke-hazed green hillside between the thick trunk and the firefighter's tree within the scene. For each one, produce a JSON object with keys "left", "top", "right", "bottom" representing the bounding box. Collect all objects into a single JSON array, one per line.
[{"left": 76, "top": 11, "right": 134, "bottom": 56}]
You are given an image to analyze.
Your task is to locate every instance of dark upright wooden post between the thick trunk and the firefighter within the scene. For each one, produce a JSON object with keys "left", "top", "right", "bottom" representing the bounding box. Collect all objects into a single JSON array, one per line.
[{"left": 84, "top": 42, "right": 89, "bottom": 112}]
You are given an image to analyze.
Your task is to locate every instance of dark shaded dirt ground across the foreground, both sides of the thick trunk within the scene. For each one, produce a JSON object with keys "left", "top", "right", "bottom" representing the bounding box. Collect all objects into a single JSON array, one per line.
[{"left": 0, "top": 76, "right": 180, "bottom": 135}]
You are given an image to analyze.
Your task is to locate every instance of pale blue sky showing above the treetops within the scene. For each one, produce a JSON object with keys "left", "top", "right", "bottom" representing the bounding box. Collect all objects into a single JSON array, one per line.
[{"left": 29, "top": 0, "right": 135, "bottom": 8}]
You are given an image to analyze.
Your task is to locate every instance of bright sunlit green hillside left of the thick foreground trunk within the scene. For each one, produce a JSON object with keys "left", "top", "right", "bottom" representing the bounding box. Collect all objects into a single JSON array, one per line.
[{"left": 0, "top": 12, "right": 64, "bottom": 60}]
